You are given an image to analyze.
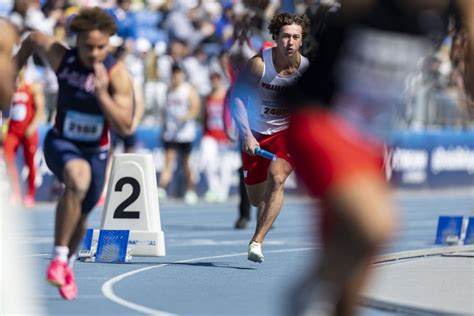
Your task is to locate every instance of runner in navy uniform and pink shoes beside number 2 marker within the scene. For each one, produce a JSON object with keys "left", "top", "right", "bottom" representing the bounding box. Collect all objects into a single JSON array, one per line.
[{"left": 17, "top": 8, "right": 133, "bottom": 299}]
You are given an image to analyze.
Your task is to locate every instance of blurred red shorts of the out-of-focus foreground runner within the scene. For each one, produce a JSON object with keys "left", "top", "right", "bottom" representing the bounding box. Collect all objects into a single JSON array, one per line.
[{"left": 288, "top": 107, "right": 384, "bottom": 197}]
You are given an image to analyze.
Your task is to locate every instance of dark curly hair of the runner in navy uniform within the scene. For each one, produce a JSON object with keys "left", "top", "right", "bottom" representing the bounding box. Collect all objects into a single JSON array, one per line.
[{"left": 69, "top": 7, "right": 117, "bottom": 36}]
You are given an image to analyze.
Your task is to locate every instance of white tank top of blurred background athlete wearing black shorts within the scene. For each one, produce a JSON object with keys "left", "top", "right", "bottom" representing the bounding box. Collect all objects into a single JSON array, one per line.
[{"left": 163, "top": 83, "right": 196, "bottom": 143}]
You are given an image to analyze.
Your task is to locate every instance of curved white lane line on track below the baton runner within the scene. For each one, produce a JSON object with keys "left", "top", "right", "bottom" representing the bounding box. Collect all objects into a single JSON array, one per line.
[{"left": 102, "top": 247, "right": 318, "bottom": 316}]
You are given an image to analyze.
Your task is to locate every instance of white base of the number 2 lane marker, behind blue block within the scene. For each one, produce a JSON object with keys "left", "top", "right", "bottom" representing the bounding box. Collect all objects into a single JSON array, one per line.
[{"left": 92, "top": 229, "right": 166, "bottom": 257}]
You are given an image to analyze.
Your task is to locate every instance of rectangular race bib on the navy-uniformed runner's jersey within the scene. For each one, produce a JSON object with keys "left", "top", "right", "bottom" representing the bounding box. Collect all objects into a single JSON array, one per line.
[{"left": 63, "top": 111, "right": 104, "bottom": 142}]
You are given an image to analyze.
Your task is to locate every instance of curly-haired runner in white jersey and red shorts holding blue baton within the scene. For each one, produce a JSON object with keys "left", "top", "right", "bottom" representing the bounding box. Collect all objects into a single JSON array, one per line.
[{"left": 230, "top": 12, "right": 309, "bottom": 263}]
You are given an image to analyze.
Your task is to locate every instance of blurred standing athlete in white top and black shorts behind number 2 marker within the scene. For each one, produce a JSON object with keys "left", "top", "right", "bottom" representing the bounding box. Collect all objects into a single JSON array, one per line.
[{"left": 158, "top": 65, "right": 200, "bottom": 204}]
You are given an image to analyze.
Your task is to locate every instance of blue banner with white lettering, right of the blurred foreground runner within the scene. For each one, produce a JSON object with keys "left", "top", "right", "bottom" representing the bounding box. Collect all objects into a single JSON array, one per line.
[{"left": 388, "top": 129, "right": 474, "bottom": 188}]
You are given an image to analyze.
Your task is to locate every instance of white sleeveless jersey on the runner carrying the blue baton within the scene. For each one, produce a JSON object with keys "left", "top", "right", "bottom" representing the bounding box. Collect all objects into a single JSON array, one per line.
[{"left": 247, "top": 48, "right": 309, "bottom": 135}]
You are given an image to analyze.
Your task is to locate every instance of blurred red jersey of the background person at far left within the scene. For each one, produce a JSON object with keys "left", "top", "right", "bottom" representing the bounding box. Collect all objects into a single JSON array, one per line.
[{"left": 8, "top": 84, "right": 35, "bottom": 136}]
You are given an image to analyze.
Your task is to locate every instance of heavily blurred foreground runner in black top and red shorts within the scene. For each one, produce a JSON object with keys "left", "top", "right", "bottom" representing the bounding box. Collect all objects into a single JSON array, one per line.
[{"left": 286, "top": 0, "right": 472, "bottom": 315}]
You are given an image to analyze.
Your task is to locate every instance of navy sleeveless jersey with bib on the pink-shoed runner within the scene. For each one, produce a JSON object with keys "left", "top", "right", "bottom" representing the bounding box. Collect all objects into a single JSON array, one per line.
[{"left": 54, "top": 49, "right": 117, "bottom": 147}]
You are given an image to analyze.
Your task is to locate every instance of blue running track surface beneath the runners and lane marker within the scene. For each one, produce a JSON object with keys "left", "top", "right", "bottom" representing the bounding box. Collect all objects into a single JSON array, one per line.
[{"left": 15, "top": 189, "right": 474, "bottom": 316}]
